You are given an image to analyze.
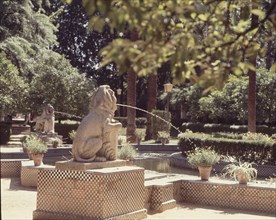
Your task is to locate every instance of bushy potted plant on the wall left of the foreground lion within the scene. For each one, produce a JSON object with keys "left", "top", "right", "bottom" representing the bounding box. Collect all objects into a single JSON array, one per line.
[{"left": 23, "top": 135, "right": 48, "bottom": 166}]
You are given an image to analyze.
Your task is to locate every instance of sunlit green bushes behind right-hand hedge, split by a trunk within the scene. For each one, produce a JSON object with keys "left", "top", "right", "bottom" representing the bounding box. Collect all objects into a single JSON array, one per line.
[{"left": 171, "top": 68, "right": 276, "bottom": 125}]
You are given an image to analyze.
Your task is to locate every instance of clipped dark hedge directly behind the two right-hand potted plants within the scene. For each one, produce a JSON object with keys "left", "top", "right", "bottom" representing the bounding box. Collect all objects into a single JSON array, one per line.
[{"left": 178, "top": 132, "right": 276, "bottom": 164}]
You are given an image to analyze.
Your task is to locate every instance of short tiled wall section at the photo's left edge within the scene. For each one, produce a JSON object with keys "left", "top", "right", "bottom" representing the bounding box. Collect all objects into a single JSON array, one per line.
[{"left": 1, "top": 160, "right": 21, "bottom": 178}]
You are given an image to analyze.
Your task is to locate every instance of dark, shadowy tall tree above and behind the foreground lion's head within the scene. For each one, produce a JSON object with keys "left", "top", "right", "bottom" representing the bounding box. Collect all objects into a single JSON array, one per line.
[{"left": 54, "top": 0, "right": 123, "bottom": 89}]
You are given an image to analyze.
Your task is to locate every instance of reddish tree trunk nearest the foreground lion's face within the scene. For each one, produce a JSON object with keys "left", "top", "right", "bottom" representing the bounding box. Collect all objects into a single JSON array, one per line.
[{"left": 126, "top": 29, "right": 138, "bottom": 143}]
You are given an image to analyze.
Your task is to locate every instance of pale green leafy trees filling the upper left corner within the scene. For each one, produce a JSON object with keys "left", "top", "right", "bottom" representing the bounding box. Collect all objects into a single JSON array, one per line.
[{"left": 0, "top": 0, "right": 94, "bottom": 115}]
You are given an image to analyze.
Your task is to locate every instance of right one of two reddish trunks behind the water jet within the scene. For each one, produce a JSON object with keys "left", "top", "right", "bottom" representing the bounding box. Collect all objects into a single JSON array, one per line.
[{"left": 145, "top": 74, "right": 157, "bottom": 140}]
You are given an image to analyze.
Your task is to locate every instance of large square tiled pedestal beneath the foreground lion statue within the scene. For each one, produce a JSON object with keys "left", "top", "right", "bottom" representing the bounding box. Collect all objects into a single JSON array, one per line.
[{"left": 33, "top": 166, "right": 147, "bottom": 220}]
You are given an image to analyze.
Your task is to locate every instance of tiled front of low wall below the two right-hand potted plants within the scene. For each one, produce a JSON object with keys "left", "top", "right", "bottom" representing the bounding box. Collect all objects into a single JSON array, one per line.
[{"left": 181, "top": 180, "right": 276, "bottom": 215}]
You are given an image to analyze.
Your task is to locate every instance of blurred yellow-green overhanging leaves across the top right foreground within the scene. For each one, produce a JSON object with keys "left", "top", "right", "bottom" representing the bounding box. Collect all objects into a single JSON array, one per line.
[{"left": 74, "top": 0, "right": 276, "bottom": 87}]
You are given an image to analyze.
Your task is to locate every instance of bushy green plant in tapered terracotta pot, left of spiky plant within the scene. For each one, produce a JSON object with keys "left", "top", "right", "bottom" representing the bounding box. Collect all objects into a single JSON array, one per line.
[{"left": 187, "top": 147, "right": 220, "bottom": 180}]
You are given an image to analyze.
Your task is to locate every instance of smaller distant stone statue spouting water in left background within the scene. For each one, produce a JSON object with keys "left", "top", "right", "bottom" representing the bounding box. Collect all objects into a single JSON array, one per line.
[{"left": 34, "top": 104, "right": 55, "bottom": 133}]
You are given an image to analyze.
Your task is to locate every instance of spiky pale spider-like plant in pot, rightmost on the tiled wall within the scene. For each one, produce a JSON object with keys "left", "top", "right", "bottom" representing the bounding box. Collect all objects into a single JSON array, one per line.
[{"left": 223, "top": 161, "right": 257, "bottom": 184}]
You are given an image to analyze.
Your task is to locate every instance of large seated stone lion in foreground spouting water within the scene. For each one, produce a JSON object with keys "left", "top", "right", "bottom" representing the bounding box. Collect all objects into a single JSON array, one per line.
[{"left": 72, "top": 85, "right": 122, "bottom": 162}]
